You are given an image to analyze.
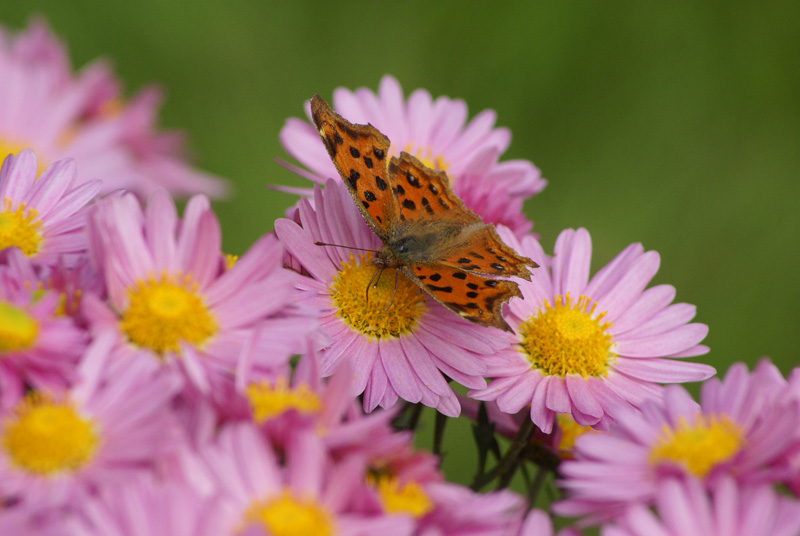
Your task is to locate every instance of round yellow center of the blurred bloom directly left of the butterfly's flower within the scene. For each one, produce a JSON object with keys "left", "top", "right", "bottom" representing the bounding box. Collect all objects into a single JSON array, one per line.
[{"left": 120, "top": 274, "right": 218, "bottom": 356}]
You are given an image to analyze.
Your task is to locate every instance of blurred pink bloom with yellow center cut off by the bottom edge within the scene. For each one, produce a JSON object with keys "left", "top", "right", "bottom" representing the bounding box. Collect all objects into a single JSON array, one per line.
[{"left": 200, "top": 423, "right": 412, "bottom": 536}]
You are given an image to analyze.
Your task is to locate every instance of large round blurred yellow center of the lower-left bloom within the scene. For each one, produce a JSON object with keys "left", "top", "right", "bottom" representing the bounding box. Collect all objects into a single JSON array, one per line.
[{"left": 2, "top": 392, "right": 99, "bottom": 475}]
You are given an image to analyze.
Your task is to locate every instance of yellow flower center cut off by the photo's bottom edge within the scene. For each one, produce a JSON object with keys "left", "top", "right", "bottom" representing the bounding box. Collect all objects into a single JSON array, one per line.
[{"left": 244, "top": 489, "right": 334, "bottom": 536}]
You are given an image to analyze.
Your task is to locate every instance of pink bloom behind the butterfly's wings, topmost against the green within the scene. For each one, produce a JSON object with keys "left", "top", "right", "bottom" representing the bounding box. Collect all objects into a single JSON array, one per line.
[{"left": 280, "top": 76, "right": 546, "bottom": 235}]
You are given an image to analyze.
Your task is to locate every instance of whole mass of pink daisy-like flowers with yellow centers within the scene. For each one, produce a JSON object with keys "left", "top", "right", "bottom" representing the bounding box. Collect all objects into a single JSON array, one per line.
[{"left": 0, "top": 16, "right": 800, "bottom": 536}]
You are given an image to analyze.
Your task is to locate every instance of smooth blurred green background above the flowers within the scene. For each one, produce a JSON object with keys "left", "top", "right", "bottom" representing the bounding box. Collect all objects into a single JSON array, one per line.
[{"left": 0, "top": 0, "right": 800, "bottom": 486}]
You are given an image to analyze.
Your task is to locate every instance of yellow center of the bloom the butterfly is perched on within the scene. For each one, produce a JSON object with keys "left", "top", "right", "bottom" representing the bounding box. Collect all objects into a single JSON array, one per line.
[{"left": 329, "top": 254, "right": 427, "bottom": 340}]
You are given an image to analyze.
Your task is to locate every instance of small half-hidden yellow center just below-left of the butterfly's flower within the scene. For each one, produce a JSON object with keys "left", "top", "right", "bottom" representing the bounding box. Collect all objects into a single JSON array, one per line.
[{"left": 245, "top": 378, "right": 322, "bottom": 423}]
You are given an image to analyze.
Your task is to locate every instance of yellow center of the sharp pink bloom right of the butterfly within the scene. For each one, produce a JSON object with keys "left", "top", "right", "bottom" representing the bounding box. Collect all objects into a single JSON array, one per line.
[{"left": 519, "top": 294, "right": 615, "bottom": 378}]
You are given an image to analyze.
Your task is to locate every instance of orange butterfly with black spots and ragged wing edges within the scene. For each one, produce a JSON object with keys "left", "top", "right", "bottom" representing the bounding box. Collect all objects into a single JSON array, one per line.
[{"left": 311, "top": 95, "right": 538, "bottom": 331}]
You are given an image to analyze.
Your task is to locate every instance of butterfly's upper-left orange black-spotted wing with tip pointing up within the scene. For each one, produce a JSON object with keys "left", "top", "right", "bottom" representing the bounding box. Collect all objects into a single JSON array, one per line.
[{"left": 311, "top": 95, "right": 397, "bottom": 242}]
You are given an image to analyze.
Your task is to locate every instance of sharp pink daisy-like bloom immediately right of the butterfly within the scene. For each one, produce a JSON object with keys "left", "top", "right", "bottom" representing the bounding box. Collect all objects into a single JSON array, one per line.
[{"left": 469, "top": 228, "right": 714, "bottom": 433}]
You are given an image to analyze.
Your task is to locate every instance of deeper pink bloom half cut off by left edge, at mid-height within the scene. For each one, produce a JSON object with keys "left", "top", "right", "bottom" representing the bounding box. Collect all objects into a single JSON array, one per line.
[{"left": 0, "top": 249, "right": 87, "bottom": 408}]
